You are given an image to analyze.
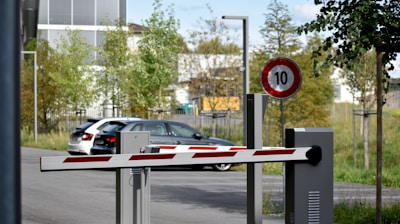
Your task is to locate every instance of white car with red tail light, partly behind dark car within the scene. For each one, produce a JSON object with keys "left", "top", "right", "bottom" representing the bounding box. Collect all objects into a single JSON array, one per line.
[{"left": 68, "top": 117, "right": 141, "bottom": 155}]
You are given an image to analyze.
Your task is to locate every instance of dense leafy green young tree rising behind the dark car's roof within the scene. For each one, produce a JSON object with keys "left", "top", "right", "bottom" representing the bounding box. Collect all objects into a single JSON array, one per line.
[{"left": 132, "top": 0, "right": 180, "bottom": 117}]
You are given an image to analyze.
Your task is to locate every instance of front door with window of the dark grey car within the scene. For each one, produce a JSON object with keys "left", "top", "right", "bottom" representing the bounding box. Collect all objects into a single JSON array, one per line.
[{"left": 168, "top": 122, "right": 209, "bottom": 145}]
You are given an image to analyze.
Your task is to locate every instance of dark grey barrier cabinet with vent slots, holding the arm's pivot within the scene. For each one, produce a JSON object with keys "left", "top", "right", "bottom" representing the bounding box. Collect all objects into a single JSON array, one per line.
[{"left": 285, "top": 128, "right": 333, "bottom": 224}]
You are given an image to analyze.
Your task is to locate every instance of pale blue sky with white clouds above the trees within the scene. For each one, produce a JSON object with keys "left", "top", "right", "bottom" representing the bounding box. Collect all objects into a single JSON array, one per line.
[{"left": 127, "top": 0, "right": 400, "bottom": 78}]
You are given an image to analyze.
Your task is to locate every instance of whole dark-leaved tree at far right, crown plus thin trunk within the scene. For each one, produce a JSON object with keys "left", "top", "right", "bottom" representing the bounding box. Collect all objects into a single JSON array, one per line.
[{"left": 299, "top": 0, "right": 400, "bottom": 223}]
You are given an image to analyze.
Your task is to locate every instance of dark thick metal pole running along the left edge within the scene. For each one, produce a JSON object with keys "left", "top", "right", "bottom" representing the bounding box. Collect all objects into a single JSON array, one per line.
[{"left": 0, "top": 0, "right": 21, "bottom": 224}]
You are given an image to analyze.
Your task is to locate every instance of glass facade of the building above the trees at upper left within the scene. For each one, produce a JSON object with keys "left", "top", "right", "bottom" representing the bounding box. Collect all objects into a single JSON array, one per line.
[{"left": 38, "top": 0, "right": 127, "bottom": 53}]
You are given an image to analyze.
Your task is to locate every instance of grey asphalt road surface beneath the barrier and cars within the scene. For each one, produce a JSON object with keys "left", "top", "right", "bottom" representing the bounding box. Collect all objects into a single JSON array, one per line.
[{"left": 21, "top": 148, "right": 400, "bottom": 224}]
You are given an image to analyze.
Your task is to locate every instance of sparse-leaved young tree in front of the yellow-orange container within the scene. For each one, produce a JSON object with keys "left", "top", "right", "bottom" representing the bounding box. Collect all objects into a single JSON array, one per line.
[{"left": 181, "top": 5, "right": 242, "bottom": 136}]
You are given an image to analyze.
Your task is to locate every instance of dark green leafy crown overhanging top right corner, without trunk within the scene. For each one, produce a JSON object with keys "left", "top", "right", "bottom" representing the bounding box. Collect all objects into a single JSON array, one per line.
[{"left": 298, "top": 0, "right": 400, "bottom": 76}]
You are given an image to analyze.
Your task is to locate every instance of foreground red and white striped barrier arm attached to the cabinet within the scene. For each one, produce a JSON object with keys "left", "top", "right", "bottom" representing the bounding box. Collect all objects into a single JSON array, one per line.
[{"left": 40, "top": 146, "right": 321, "bottom": 171}]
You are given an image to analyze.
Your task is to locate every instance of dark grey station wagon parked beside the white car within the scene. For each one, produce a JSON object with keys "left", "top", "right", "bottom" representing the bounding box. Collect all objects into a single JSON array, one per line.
[{"left": 90, "top": 120, "right": 237, "bottom": 171}]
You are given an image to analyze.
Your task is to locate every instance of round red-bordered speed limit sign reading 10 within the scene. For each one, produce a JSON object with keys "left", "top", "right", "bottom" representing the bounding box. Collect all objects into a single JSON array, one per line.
[{"left": 260, "top": 57, "right": 301, "bottom": 99}]
